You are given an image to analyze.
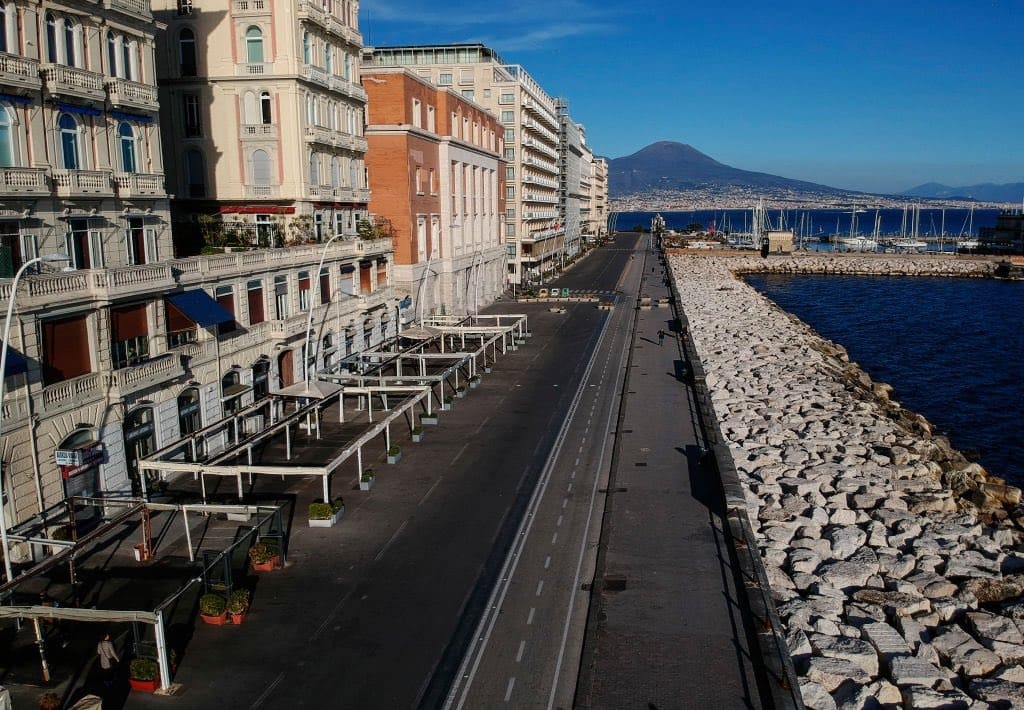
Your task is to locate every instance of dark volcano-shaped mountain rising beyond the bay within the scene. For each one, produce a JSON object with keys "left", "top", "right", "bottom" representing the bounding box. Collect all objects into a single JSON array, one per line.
[{"left": 608, "top": 140, "right": 850, "bottom": 197}]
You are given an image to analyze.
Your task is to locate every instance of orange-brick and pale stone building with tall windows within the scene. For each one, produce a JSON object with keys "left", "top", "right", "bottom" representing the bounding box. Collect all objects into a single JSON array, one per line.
[{"left": 362, "top": 67, "right": 506, "bottom": 318}]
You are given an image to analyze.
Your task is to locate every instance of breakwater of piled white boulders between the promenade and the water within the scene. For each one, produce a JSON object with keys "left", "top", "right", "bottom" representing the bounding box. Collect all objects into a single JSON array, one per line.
[{"left": 670, "top": 255, "right": 1024, "bottom": 709}]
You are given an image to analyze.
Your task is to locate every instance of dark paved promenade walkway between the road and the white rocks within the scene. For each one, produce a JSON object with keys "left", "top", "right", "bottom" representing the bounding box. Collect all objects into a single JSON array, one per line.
[{"left": 575, "top": 237, "right": 763, "bottom": 709}]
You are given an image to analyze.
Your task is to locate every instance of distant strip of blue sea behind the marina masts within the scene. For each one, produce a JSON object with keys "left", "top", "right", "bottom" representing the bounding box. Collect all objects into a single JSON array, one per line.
[{"left": 611, "top": 207, "right": 999, "bottom": 241}]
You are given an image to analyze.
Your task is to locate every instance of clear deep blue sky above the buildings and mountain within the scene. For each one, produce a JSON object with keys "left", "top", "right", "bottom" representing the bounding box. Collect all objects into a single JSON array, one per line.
[{"left": 359, "top": 0, "right": 1024, "bottom": 192}]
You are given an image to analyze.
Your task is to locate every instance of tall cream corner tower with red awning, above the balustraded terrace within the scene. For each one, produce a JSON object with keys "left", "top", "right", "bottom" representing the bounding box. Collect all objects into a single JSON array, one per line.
[{"left": 154, "top": 0, "right": 370, "bottom": 248}]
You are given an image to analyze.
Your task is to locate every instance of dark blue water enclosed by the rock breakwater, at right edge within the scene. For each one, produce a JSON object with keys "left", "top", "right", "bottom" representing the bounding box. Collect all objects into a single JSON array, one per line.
[{"left": 748, "top": 275, "right": 1024, "bottom": 486}]
